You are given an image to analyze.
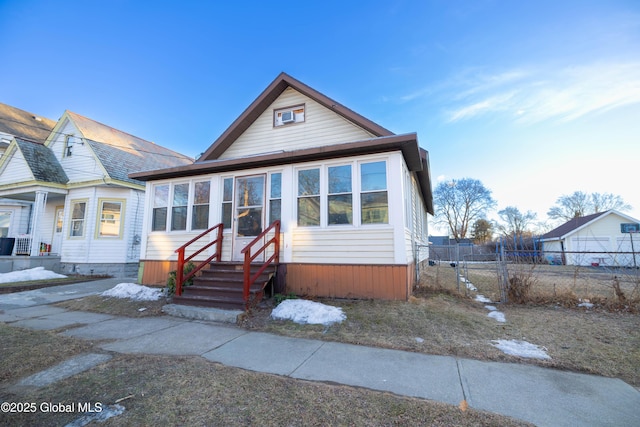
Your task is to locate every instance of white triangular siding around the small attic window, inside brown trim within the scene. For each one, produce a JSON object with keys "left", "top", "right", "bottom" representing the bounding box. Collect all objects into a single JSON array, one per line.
[{"left": 220, "top": 88, "right": 374, "bottom": 159}]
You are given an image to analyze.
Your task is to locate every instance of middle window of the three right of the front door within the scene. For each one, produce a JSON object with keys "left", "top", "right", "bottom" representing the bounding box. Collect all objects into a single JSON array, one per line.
[{"left": 327, "top": 165, "right": 353, "bottom": 225}]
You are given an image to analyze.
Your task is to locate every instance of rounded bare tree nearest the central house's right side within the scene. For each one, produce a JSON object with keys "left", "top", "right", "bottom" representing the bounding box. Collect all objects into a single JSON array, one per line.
[{"left": 433, "top": 178, "right": 496, "bottom": 242}]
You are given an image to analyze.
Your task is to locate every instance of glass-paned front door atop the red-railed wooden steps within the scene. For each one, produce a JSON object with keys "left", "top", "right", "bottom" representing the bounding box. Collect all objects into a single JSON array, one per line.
[{"left": 233, "top": 175, "right": 265, "bottom": 261}]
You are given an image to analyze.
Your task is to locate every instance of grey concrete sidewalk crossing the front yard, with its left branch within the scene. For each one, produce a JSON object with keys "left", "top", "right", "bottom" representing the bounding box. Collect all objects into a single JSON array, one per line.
[{"left": 0, "top": 279, "right": 640, "bottom": 426}]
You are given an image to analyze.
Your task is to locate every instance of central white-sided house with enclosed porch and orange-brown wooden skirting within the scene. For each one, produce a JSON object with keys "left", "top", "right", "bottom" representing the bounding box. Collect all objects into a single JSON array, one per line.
[{"left": 130, "top": 73, "right": 433, "bottom": 300}]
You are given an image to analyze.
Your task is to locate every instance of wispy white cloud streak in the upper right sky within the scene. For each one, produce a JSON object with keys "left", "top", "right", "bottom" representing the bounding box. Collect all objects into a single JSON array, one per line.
[{"left": 441, "top": 62, "right": 640, "bottom": 123}]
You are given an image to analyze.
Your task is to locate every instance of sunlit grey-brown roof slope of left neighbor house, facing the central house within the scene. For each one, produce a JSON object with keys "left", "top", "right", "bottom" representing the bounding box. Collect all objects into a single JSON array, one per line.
[{"left": 60, "top": 111, "right": 193, "bottom": 184}]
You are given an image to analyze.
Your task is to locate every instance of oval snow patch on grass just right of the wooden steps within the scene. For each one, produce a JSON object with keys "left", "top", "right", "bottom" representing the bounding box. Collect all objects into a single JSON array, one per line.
[{"left": 271, "top": 299, "right": 347, "bottom": 326}]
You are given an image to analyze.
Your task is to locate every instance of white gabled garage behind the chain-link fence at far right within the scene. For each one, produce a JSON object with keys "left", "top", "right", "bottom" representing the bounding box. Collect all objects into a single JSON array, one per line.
[{"left": 541, "top": 210, "right": 640, "bottom": 267}]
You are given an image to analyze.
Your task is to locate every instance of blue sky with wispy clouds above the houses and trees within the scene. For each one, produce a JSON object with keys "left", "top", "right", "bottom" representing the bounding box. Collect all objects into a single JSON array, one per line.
[{"left": 0, "top": 0, "right": 640, "bottom": 234}]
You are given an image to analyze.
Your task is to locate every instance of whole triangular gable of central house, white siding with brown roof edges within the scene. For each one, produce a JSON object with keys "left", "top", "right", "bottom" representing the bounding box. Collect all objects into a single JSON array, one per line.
[{"left": 198, "top": 73, "right": 393, "bottom": 162}]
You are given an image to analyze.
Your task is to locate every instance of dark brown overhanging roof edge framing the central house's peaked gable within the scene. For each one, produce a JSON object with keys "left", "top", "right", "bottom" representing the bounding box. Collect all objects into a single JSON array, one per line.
[{"left": 201, "top": 72, "right": 393, "bottom": 162}]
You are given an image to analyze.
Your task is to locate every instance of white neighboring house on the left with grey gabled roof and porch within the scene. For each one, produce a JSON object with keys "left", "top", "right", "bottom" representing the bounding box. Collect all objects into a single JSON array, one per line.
[{"left": 0, "top": 105, "right": 193, "bottom": 277}]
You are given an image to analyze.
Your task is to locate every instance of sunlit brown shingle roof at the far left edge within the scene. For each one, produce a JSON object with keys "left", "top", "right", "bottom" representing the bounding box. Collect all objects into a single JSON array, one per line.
[{"left": 0, "top": 103, "right": 56, "bottom": 144}]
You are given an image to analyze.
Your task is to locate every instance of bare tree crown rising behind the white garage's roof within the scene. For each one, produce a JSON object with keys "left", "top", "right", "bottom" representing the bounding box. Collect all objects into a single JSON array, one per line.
[{"left": 547, "top": 191, "right": 631, "bottom": 221}]
